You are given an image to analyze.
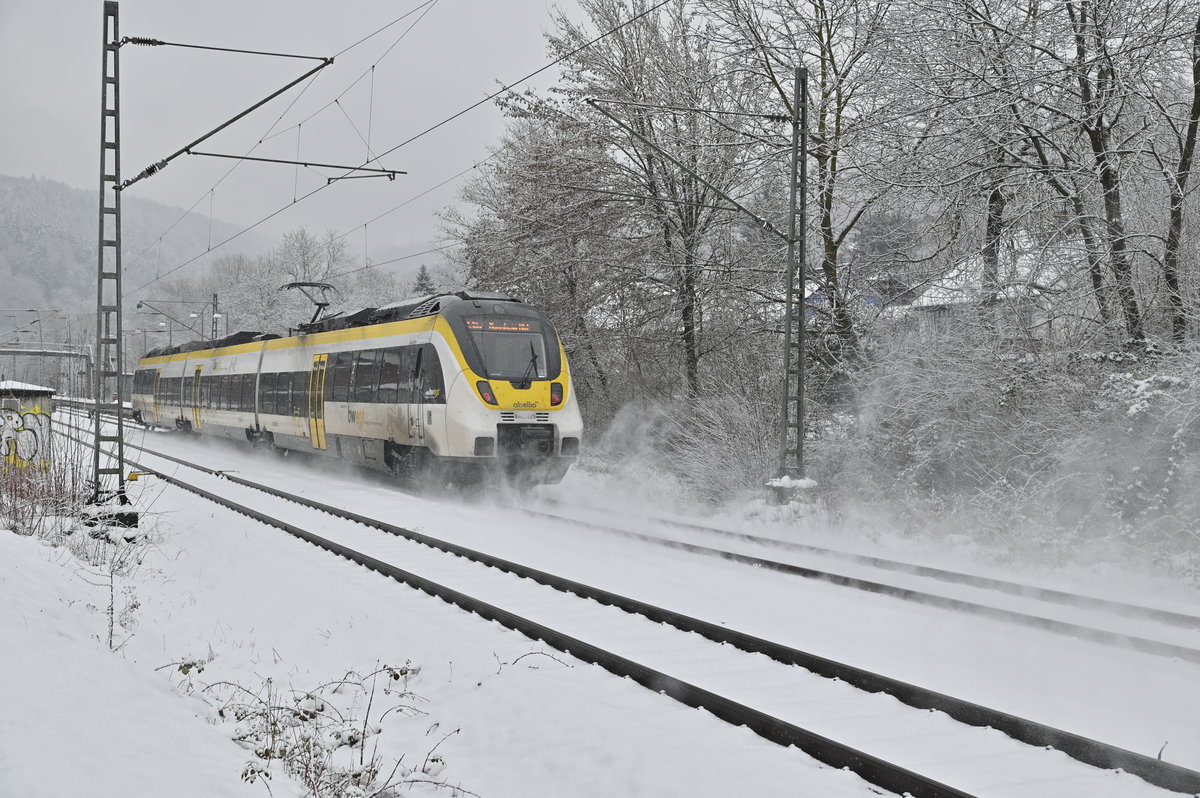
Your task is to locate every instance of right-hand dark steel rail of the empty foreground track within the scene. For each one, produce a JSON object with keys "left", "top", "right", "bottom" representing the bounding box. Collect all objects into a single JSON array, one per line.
[{"left": 79, "top": 429, "right": 1200, "bottom": 794}]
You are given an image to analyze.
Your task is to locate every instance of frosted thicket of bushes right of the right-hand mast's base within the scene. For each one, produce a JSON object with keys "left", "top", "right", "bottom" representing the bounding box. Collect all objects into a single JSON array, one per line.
[{"left": 810, "top": 328, "right": 1200, "bottom": 581}]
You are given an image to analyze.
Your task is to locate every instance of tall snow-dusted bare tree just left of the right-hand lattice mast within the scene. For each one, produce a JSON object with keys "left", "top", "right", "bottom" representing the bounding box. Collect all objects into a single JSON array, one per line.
[{"left": 550, "top": 0, "right": 762, "bottom": 396}]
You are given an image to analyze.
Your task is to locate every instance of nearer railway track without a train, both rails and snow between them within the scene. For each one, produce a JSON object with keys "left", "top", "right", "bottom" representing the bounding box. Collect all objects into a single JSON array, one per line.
[{"left": 72, "top": 420, "right": 1200, "bottom": 794}]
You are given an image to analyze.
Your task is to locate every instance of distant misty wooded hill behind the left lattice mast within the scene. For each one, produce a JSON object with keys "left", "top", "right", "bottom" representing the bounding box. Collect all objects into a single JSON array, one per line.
[{"left": 0, "top": 175, "right": 254, "bottom": 313}]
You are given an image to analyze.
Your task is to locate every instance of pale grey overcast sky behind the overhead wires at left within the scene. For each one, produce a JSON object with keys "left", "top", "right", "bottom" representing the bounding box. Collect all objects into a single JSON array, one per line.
[{"left": 0, "top": 0, "right": 578, "bottom": 267}]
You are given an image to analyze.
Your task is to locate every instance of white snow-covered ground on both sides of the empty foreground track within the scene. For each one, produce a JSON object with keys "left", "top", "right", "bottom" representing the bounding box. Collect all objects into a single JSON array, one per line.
[{"left": 0, "top": 420, "right": 1200, "bottom": 798}]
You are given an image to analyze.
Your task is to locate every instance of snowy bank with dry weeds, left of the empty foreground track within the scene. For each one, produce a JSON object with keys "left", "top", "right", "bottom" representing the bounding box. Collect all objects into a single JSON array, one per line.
[{"left": 0, "top": 468, "right": 872, "bottom": 798}]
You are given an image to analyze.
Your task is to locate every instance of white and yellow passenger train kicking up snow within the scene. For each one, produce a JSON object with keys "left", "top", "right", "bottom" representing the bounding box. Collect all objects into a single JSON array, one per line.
[{"left": 133, "top": 292, "right": 583, "bottom": 484}]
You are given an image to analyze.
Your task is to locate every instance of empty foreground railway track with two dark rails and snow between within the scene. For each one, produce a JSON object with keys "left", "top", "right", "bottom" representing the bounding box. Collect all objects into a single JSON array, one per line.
[{"left": 72, "top": 420, "right": 1200, "bottom": 796}]
